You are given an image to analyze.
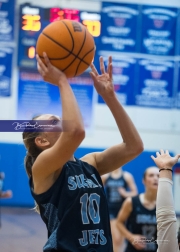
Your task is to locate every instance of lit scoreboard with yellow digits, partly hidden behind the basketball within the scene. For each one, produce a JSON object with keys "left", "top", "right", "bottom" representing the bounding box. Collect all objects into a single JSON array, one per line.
[{"left": 18, "top": 4, "right": 101, "bottom": 69}]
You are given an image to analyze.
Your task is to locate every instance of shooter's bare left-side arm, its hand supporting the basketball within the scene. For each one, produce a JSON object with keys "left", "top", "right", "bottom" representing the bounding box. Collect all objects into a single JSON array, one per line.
[{"left": 32, "top": 53, "right": 85, "bottom": 181}]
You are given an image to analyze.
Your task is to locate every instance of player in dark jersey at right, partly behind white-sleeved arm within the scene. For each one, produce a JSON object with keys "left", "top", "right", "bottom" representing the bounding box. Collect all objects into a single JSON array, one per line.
[{"left": 117, "top": 167, "right": 159, "bottom": 252}]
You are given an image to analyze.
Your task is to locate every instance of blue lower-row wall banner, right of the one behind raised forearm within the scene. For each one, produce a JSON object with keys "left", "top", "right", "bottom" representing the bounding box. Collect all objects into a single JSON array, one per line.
[{"left": 135, "top": 59, "right": 174, "bottom": 108}]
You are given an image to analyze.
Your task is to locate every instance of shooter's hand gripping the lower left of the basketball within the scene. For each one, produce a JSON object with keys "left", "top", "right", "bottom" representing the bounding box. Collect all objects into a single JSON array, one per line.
[{"left": 36, "top": 52, "right": 67, "bottom": 86}]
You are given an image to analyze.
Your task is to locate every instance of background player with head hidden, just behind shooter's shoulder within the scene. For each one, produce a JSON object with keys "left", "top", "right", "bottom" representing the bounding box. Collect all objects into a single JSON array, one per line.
[{"left": 102, "top": 167, "right": 138, "bottom": 252}]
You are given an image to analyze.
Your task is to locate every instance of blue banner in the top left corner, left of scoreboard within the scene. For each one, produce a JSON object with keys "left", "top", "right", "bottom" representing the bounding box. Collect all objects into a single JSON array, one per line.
[{"left": 0, "top": 0, "right": 15, "bottom": 42}]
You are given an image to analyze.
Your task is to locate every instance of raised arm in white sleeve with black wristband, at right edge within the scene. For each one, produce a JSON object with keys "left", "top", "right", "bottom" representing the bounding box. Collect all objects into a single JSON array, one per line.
[{"left": 151, "top": 150, "right": 180, "bottom": 252}]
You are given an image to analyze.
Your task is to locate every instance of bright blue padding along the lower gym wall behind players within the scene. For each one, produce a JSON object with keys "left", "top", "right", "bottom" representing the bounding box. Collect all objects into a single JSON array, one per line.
[{"left": 0, "top": 143, "right": 165, "bottom": 207}]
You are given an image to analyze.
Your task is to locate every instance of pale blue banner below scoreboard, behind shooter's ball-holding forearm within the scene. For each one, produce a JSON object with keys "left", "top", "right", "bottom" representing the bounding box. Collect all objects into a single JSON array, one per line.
[{"left": 17, "top": 71, "right": 96, "bottom": 132}]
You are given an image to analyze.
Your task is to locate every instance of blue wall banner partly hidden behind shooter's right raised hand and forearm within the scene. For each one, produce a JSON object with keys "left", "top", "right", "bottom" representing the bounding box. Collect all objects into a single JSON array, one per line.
[{"left": 98, "top": 52, "right": 137, "bottom": 105}]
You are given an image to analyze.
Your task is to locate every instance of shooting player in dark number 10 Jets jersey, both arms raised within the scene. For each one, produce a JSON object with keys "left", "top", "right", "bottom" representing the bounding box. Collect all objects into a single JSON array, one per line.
[{"left": 23, "top": 53, "right": 143, "bottom": 252}]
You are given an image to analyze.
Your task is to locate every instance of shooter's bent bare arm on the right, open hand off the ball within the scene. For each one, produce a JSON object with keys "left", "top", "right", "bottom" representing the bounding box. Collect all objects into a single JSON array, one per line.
[{"left": 83, "top": 57, "right": 143, "bottom": 175}]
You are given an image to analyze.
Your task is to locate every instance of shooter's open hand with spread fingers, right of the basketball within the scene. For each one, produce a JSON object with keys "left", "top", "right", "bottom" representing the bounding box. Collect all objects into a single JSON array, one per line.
[{"left": 90, "top": 56, "right": 114, "bottom": 97}]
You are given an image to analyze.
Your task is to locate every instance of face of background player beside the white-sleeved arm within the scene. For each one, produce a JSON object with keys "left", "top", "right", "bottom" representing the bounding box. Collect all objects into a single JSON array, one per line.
[{"left": 143, "top": 167, "right": 159, "bottom": 190}]
